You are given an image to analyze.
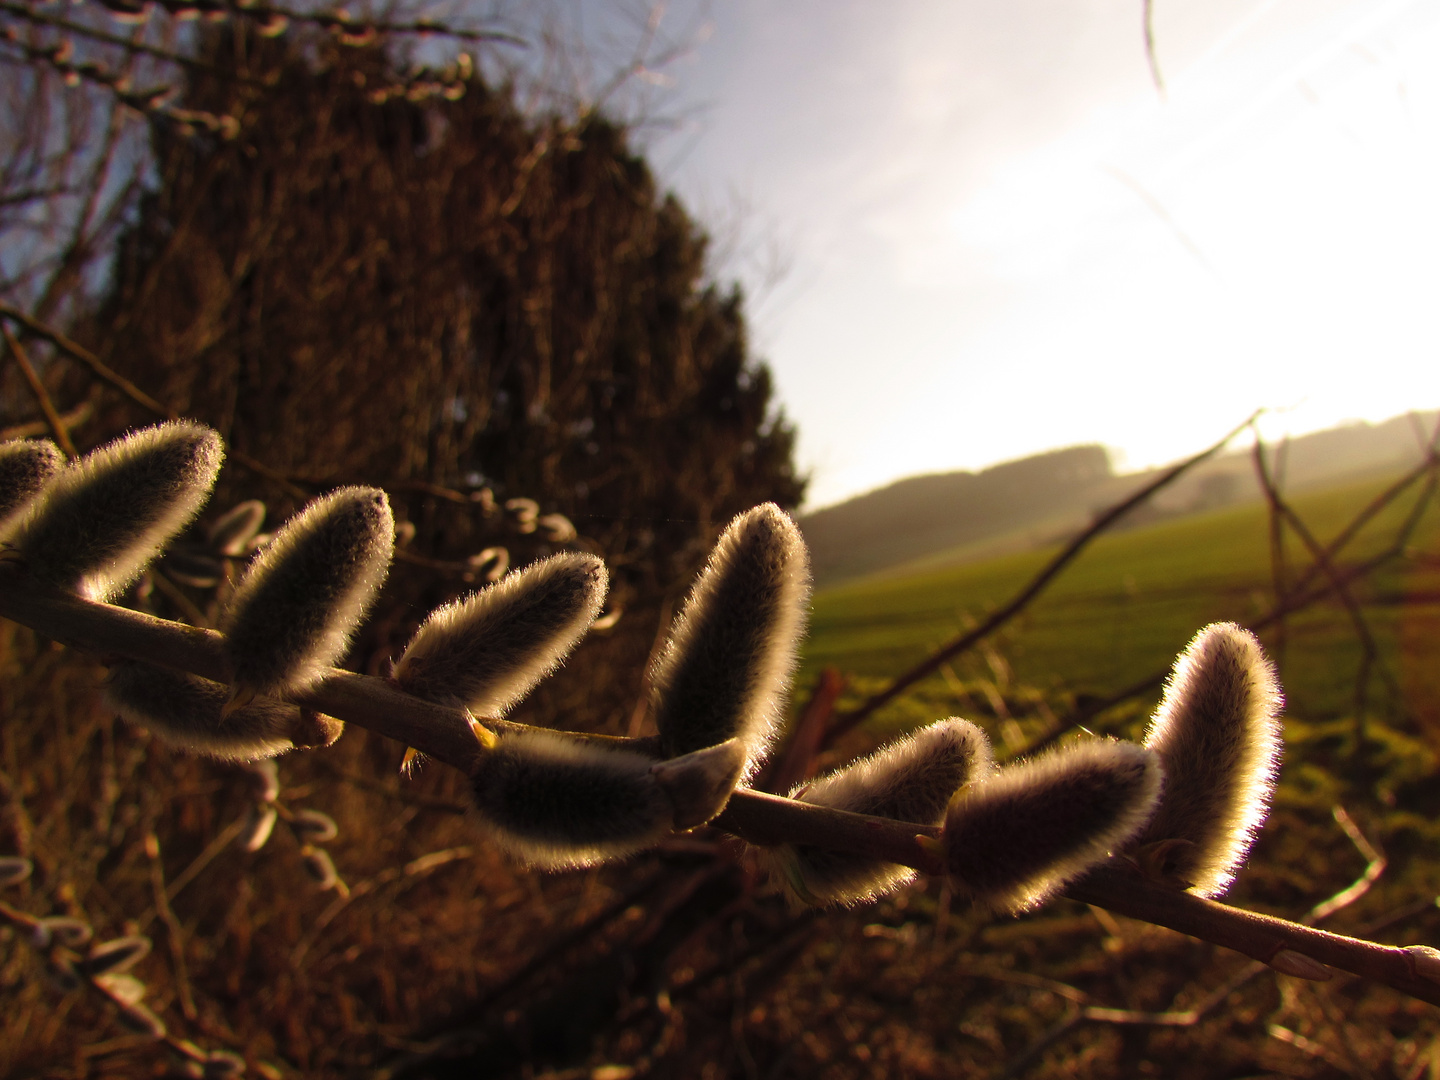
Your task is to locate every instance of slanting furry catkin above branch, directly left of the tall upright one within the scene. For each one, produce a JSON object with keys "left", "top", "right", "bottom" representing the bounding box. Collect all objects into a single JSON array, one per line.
[{"left": 395, "top": 554, "right": 608, "bottom": 717}]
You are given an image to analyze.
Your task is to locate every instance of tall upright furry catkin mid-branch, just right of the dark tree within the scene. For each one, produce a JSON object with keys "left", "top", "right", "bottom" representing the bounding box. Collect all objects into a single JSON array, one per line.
[{"left": 651, "top": 503, "right": 809, "bottom": 775}]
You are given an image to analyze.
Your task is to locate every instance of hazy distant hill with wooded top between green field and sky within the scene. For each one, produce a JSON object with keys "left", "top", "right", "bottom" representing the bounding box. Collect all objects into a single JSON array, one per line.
[{"left": 799, "top": 412, "right": 1437, "bottom": 586}]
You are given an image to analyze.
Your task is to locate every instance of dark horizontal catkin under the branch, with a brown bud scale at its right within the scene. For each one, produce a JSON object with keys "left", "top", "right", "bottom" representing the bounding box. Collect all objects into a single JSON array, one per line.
[{"left": 471, "top": 730, "right": 674, "bottom": 868}]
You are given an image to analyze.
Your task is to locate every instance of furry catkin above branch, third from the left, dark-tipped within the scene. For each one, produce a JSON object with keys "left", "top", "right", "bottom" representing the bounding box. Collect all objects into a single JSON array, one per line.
[{"left": 220, "top": 488, "right": 395, "bottom": 696}]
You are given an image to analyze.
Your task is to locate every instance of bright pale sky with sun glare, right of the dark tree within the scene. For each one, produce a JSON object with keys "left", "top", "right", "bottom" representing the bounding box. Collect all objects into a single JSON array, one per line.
[{"left": 561, "top": 0, "right": 1440, "bottom": 508}]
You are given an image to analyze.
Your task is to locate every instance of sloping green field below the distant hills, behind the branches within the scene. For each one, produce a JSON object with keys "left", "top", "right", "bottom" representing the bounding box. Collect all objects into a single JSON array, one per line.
[{"left": 799, "top": 478, "right": 1440, "bottom": 743}]
